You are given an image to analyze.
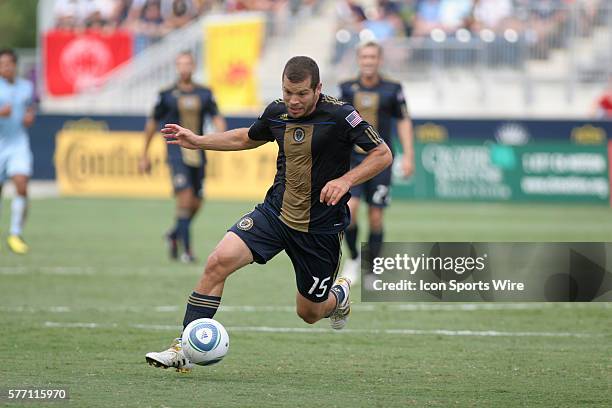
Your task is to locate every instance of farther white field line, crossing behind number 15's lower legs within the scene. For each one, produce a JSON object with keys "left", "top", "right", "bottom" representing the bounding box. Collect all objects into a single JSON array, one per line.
[{"left": 0, "top": 302, "right": 612, "bottom": 313}]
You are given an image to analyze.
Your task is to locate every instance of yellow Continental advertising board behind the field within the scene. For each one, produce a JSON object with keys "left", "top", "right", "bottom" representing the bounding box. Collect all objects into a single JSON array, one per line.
[{"left": 54, "top": 130, "right": 278, "bottom": 200}]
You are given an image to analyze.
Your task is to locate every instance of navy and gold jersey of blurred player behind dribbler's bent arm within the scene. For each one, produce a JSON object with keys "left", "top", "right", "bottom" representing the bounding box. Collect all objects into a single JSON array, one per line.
[{"left": 340, "top": 78, "right": 409, "bottom": 153}]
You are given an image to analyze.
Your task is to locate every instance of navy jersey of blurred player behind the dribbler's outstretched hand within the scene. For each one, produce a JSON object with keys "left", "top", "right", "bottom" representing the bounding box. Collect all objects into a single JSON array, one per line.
[{"left": 152, "top": 84, "right": 219, "bottom": 167}]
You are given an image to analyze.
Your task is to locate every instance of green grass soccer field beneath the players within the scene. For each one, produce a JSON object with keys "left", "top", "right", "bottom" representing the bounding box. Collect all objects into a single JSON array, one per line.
[{"left": 0, "top": 199, "right": 612, "bottom": 407}]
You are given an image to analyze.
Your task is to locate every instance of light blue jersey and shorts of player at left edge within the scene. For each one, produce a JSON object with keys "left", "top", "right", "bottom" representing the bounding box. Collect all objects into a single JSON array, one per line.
[{"left": 0, "top": 78, "right": 34, "bottom": 183}]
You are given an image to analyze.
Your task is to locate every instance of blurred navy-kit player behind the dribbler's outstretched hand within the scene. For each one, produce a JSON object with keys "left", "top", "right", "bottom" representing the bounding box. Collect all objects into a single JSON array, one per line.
[{"left": 140, "top": 52, "right": 226, "bottom": 263}]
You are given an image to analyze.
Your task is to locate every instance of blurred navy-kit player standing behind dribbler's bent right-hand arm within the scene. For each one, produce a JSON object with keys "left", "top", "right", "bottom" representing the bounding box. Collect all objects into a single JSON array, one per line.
[{"left": 340, "top": 42, "right": 414, "bottom": 282}]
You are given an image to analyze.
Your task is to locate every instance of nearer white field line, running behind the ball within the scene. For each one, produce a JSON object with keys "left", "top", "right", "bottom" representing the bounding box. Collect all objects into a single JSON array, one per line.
[{"left": 44, "top": 322, "right": 603, "bottom": 338}]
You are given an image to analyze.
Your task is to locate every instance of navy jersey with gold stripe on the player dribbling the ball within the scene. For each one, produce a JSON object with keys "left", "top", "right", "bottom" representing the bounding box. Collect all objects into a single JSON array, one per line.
[{"left": 249, "top": 94, "right": 384, "bottom": 234}]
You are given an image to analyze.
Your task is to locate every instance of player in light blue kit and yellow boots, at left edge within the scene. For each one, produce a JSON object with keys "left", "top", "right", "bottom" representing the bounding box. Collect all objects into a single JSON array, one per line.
[{"left": 0, "top": 49, "right": 36, "bottom": 255}]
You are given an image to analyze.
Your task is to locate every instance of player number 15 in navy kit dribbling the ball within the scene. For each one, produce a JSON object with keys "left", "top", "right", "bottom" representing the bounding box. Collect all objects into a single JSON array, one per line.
[{"left": 146, "top": 57, "right": 392, "bottom": 370}]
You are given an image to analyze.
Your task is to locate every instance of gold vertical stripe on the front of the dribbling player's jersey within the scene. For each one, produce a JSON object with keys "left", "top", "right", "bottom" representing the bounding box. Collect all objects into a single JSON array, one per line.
[{"left": 280, "top": 124, "right": 314, "bottom": 232}]
